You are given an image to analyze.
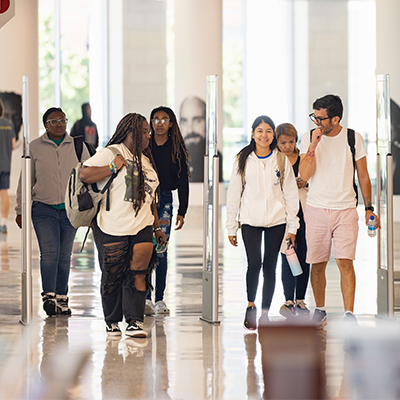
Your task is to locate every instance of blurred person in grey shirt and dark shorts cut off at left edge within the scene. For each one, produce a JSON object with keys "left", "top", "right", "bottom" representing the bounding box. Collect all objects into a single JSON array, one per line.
[{"left": 0, "top": 99, "right": 15, "bottom": 233}]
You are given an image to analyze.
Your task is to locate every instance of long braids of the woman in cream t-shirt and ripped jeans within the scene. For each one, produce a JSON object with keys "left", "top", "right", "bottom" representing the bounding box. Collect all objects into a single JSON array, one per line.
[{"left": 106, "top": 113, "right": 158, "bottom": 215}]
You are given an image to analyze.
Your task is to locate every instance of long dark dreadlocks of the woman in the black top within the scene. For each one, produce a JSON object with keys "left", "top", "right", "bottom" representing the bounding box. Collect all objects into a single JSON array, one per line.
[{"left": 150, "top": 106, "right": 192, "bottom": 178}]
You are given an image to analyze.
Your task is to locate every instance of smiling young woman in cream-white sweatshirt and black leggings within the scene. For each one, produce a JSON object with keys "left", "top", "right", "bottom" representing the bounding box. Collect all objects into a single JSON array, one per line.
[{"left": 226, "top": 115, "right": 299, "bottom": 330}]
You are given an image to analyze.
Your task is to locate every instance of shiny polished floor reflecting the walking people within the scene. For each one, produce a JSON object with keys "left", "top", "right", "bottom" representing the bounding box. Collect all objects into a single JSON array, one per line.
[{"left": 0, "top": 203, "right": 400, "bottom": 399}]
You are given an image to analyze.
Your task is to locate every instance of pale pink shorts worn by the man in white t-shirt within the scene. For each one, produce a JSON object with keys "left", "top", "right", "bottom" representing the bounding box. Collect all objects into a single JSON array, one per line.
[{"left": 304, "top": 204, "right": 358, "bottom": 264}]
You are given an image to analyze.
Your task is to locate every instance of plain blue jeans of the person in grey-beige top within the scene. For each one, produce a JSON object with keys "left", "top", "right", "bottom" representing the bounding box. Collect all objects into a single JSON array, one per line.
[{"left": 32, "top": 201, "right": 76, "bottom": 296}]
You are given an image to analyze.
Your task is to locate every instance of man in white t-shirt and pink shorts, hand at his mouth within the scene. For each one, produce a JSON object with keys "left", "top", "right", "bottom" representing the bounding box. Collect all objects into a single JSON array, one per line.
[{"left": 299, "top": 94, "right": 380, "bottom": 329}]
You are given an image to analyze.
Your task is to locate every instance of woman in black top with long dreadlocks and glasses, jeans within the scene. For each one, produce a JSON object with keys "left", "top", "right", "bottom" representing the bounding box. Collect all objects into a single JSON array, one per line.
[{"left": 145, "top": 106, "right": 190, "bottom": 315}]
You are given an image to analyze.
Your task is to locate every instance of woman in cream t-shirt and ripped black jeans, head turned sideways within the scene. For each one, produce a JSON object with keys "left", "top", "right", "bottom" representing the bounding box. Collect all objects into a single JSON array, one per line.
[{"left": 81, "top": 114, "right": 165, "bottom": 338}]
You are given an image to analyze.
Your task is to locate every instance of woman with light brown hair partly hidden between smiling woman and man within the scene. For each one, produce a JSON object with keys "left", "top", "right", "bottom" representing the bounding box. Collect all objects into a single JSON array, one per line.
[{"left": 276, "top": 123, "right": 310, "bottom": 318}]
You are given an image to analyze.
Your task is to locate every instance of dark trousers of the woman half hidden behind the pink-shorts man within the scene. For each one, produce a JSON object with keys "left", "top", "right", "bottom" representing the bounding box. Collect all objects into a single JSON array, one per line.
[{"left": 281, "top": 208, "right": 310, "bottom": 301}]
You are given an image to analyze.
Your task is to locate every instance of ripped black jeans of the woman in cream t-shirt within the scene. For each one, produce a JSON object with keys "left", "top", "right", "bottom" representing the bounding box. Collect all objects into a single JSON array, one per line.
[{"left": 93, "top": 223, "right": 153, "bottom": 323}]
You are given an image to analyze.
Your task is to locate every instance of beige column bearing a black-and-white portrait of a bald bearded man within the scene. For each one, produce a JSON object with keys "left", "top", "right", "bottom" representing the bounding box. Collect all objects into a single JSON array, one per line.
[{"left": 174, "top": 0, "right": 223, "bottom": 199}]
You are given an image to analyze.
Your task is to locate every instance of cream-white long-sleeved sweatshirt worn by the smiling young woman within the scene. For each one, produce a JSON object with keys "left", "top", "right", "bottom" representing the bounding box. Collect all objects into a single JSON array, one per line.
[{"left": 226, "top": 149, "right": 299, "bottom": 236}]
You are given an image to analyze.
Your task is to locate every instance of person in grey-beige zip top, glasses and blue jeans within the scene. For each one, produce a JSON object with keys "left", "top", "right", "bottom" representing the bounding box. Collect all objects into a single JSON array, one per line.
[{"left": 15, "top": 107, "right": 90, "bottom": 316}]
